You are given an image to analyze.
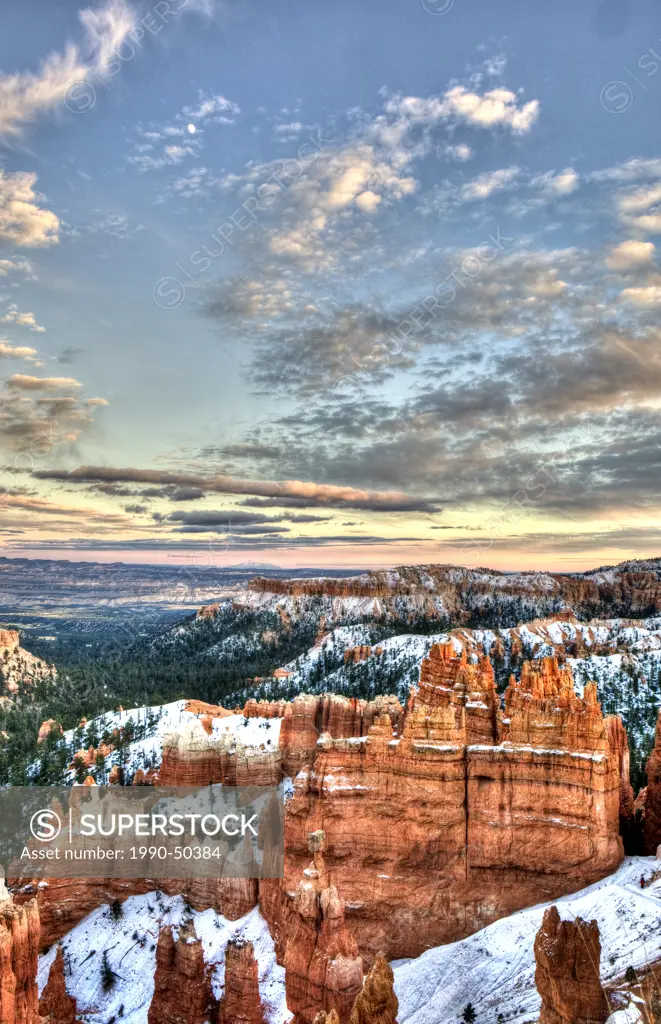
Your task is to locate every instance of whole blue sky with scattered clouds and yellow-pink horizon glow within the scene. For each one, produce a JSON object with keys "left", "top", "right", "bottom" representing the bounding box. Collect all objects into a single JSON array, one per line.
[{"left": 0, "top": 0, "right": 661, "bottom": 570}]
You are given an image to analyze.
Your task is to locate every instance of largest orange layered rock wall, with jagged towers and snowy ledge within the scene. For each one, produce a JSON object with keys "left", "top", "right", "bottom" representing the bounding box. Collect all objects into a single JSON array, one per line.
[{"left": 260, "top": 645, "right": 623, "bottom": 958}]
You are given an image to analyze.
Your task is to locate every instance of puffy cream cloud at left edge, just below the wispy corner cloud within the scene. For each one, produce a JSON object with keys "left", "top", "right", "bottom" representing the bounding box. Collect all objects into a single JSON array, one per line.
[{"left": 0, "top": 167, "right": 59, "bottom": 248}]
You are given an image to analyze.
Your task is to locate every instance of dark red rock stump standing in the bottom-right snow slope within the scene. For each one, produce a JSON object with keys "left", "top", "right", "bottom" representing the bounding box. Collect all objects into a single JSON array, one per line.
[{"left": 535, "top": 906, "right": 610, "bottom": 1024}]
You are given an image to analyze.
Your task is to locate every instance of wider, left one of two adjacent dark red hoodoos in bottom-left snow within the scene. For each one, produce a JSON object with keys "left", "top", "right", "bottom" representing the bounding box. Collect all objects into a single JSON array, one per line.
[{"left": 147, "top": 928, "right": 218, "bottom": 1024}]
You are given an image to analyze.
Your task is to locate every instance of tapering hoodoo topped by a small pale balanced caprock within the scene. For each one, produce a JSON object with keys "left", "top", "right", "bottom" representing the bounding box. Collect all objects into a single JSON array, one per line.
[{"left": 275, "top": 833, "right": 362, "bottom": 1024}]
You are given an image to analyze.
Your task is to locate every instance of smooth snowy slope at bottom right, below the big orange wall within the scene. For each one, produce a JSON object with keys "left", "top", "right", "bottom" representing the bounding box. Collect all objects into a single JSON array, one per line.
[{"left": 393, "top": 857, "right": 661, "bottom": 1024}]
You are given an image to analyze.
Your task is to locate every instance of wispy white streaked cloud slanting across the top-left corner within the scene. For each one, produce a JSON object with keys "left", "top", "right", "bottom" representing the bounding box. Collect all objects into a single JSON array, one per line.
[{"left": 0, "top": 0, "right": 136, "bottom": 138}]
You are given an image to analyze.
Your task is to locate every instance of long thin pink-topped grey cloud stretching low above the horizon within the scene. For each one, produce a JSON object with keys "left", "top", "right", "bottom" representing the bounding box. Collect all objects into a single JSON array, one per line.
[{"left": 33, "top": 466, "right": 436, "bottom": 511}]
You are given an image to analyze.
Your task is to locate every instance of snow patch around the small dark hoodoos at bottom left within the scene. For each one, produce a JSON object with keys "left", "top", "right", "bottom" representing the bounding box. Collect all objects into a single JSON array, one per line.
[{"left": 38, "top": 892, "right": 292, "bottom": 1024}]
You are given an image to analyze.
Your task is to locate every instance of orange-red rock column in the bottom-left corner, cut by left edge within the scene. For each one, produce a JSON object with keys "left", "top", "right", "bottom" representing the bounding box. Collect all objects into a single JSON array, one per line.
[{"left": 0, "top": 882, "right": 40, "bottom": 1024}]
